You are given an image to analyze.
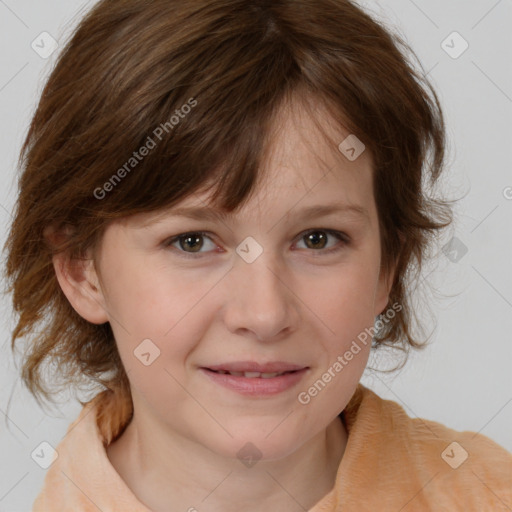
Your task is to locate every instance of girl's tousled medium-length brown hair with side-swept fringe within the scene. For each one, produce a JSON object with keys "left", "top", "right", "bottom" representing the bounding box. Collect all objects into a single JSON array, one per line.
[{"left": 6, "top": 0, "right": 451, "bottom": 408}]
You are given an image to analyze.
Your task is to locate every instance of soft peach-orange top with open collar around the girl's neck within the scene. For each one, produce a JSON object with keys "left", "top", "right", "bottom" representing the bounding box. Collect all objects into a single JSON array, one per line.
[{"left": 32, "top": 384, "right": 512, "bottom": 512}]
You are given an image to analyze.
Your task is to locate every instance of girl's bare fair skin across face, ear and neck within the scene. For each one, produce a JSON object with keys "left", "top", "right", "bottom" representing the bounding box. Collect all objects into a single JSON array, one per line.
[{"left": 54, "top": 99, "right": 392, "bottom": 512}]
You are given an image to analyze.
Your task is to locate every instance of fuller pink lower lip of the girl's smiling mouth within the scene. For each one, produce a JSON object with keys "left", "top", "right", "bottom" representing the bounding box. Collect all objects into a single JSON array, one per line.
[{"left": 200, "top": 368, "right": 307, "bottom": 396}]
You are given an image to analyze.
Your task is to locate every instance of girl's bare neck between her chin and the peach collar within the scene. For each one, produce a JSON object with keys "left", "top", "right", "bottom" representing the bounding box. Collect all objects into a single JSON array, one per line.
[{"left": 107, "top": 406, "right": 348, "bottom": 512}]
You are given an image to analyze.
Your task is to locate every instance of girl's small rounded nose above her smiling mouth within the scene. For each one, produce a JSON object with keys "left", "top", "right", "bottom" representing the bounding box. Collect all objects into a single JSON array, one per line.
[{"left": 224, "top": 252, "right": 300, "bottom": 341}]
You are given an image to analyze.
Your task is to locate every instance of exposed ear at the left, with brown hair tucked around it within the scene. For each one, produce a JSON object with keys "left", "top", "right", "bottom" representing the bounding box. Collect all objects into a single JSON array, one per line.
[{"left": 44, "top": 227, "right": 108, "bottom": 324}]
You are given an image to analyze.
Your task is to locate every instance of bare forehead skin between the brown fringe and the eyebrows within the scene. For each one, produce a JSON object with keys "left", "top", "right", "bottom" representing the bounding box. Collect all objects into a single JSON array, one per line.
[{"left": 126, "top": 97, "right": 375, "bottom": 228}]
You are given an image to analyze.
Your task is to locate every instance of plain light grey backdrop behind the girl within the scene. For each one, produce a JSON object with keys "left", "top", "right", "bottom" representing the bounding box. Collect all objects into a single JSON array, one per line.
[{"left": 0, "top": 0, "right": 512, "bottom": 512}]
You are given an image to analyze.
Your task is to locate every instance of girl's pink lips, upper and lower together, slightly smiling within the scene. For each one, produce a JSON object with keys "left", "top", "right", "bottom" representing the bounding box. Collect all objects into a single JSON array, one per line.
[{"left": 200, "top": 365, "right": 309, "bottom": 397}]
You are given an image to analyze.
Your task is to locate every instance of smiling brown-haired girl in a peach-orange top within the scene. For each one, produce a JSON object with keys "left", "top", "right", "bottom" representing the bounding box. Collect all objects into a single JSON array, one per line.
[{"left": 6, "top": 0, "right": 512, "bottom": 512}]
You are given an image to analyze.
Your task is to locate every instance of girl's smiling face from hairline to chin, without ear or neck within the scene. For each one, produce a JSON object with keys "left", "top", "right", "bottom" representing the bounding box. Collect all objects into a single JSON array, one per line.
[{"left": 65, "top": 100, "right": 391, "bottom": 459}]
